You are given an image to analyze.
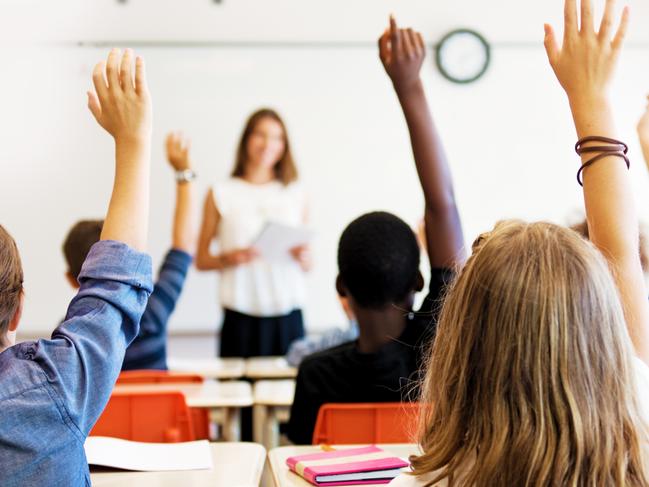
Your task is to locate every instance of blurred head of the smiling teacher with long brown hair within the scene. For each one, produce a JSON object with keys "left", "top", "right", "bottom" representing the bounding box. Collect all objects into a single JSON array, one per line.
[{"left": 232, "top": 108, "right": 297, "bottom": 184}]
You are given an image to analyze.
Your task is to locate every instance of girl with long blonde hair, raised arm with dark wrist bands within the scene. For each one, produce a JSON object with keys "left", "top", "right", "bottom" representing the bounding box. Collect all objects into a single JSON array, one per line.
[{"left": 391, "top": 0, "right": 649, "bottom": 487}]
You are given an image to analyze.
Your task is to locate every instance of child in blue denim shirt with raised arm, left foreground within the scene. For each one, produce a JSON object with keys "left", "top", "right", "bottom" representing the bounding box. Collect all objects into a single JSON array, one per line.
[{"left": 0, "top": 49, "right": 152, "bottom": 487}]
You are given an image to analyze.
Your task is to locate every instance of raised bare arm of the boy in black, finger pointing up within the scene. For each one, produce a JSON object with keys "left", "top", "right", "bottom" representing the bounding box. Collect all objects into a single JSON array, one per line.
[{"left": 379, "top": 17, "right": 465, "bottom": 268}]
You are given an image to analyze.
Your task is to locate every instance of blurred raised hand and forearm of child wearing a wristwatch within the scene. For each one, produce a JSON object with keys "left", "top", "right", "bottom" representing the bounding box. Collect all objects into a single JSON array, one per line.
[{"left": 165, "top": 132, "right": 196, "bottom": 255}]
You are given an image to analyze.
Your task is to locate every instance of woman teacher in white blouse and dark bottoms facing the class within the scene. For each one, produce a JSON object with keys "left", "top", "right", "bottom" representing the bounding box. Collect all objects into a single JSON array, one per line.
[{"left": 196, "top": 108, "right": 310, "bottom": 357}]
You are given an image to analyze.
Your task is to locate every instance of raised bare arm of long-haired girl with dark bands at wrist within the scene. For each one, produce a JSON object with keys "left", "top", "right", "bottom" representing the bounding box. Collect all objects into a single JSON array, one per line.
[{"left": 545, "top": 0, "right": 649, "bottom": 363}]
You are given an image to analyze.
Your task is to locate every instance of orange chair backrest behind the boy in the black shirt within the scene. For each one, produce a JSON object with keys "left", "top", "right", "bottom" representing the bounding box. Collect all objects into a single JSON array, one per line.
[{"left": 313, "top": 402, "right": 419, "bottom": 445}]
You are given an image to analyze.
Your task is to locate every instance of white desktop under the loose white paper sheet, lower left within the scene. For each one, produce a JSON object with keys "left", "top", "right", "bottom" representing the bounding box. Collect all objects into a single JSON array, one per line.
[{"left": 90, "top": 443, "right": 266, "bottom": 487}]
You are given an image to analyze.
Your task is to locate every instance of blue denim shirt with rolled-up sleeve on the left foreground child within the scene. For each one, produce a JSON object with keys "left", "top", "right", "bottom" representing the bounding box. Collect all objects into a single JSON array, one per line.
[{"left": 0, "top": 241, "right": 152, "bottom": 487}]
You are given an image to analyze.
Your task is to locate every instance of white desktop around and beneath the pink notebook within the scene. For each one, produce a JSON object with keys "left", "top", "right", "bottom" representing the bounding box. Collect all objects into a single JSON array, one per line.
[{"left": 268, "top": 444, "right": 418, "bottom": 487}]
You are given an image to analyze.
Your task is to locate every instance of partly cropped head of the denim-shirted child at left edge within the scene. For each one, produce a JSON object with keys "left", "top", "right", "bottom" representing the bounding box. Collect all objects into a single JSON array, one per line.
[{"left": 0, "top": 225, "right": 24, "bottom": 350}]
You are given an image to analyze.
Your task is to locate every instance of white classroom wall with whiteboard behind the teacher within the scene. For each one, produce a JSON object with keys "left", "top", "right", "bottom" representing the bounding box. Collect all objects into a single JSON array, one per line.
[{"left": 0, "top": 0, "right": 649, "bottom": 340}]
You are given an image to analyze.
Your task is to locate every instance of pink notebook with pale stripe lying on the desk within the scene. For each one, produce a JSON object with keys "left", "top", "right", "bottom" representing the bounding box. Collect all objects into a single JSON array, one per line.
[{"left": 286, "top": 446, "right": 408, "bottom": 486}]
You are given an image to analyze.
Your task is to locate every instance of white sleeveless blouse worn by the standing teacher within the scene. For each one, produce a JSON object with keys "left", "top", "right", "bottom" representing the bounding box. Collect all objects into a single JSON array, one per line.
[{"left": 213, "top": 178, "right": 306, "bottom": 317}]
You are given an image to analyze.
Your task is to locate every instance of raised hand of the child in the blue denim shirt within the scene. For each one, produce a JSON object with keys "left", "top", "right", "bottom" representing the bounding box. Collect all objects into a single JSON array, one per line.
[{"left": 88, "top": 49, "right": 152, "bottom": 140}]
